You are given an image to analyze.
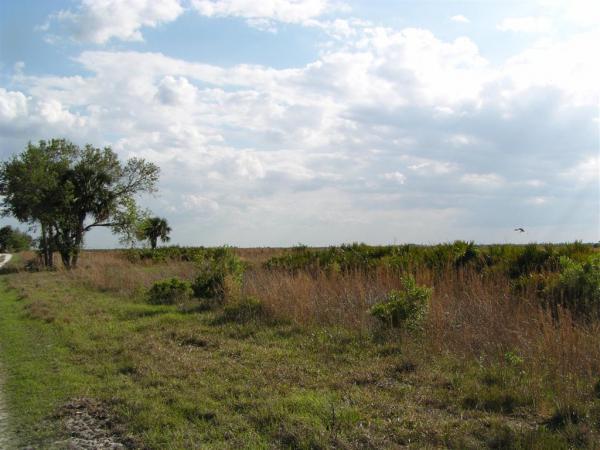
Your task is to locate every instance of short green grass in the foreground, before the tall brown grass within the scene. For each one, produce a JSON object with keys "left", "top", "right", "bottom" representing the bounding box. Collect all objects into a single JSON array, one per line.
[{"left": 0, "top": 273, "right": 600, "bottom": 449}]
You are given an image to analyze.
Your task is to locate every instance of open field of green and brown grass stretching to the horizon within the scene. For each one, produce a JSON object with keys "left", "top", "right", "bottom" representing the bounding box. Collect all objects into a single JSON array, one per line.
[{"left": 0, "top": 243, "right": 600, "bottom": 449}]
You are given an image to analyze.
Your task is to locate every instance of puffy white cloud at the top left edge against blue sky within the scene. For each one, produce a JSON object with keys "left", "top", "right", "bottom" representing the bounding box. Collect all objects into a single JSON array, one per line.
[{"left": 47, "top": 0, "right": 183, "bottom": 44}]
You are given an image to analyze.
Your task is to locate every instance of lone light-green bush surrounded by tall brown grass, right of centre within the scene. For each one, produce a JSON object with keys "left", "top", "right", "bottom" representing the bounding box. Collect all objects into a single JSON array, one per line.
[{"left": 370, "top": 276, "right": 432, "bottom": 330}]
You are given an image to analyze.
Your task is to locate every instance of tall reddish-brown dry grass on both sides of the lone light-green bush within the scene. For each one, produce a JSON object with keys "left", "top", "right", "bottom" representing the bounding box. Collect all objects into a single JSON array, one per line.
[{"left": 244, "top": 269, "right": 600, "bottom": 399}]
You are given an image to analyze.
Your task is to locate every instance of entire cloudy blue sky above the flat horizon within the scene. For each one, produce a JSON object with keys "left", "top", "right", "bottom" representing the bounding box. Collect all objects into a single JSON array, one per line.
[{"left": 0, "top": 0, "right": 600, "bottom": 248}]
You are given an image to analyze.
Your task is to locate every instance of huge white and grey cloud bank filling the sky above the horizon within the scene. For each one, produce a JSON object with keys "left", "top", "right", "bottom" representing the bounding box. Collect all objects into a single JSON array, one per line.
[{"left": 0, "top": 14, "right": 600, "bottom": 245}]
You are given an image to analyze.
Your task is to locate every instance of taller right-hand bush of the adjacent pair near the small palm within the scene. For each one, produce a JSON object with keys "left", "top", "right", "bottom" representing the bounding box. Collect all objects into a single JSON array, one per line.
[{"left": 192, "top": 247, "right": 246, "bottom": 300}]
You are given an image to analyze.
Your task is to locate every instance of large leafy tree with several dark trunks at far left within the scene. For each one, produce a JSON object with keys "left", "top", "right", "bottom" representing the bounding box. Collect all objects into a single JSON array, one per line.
[{"left": 0, "top": 139, "right": 159, "bottom": 269}]
